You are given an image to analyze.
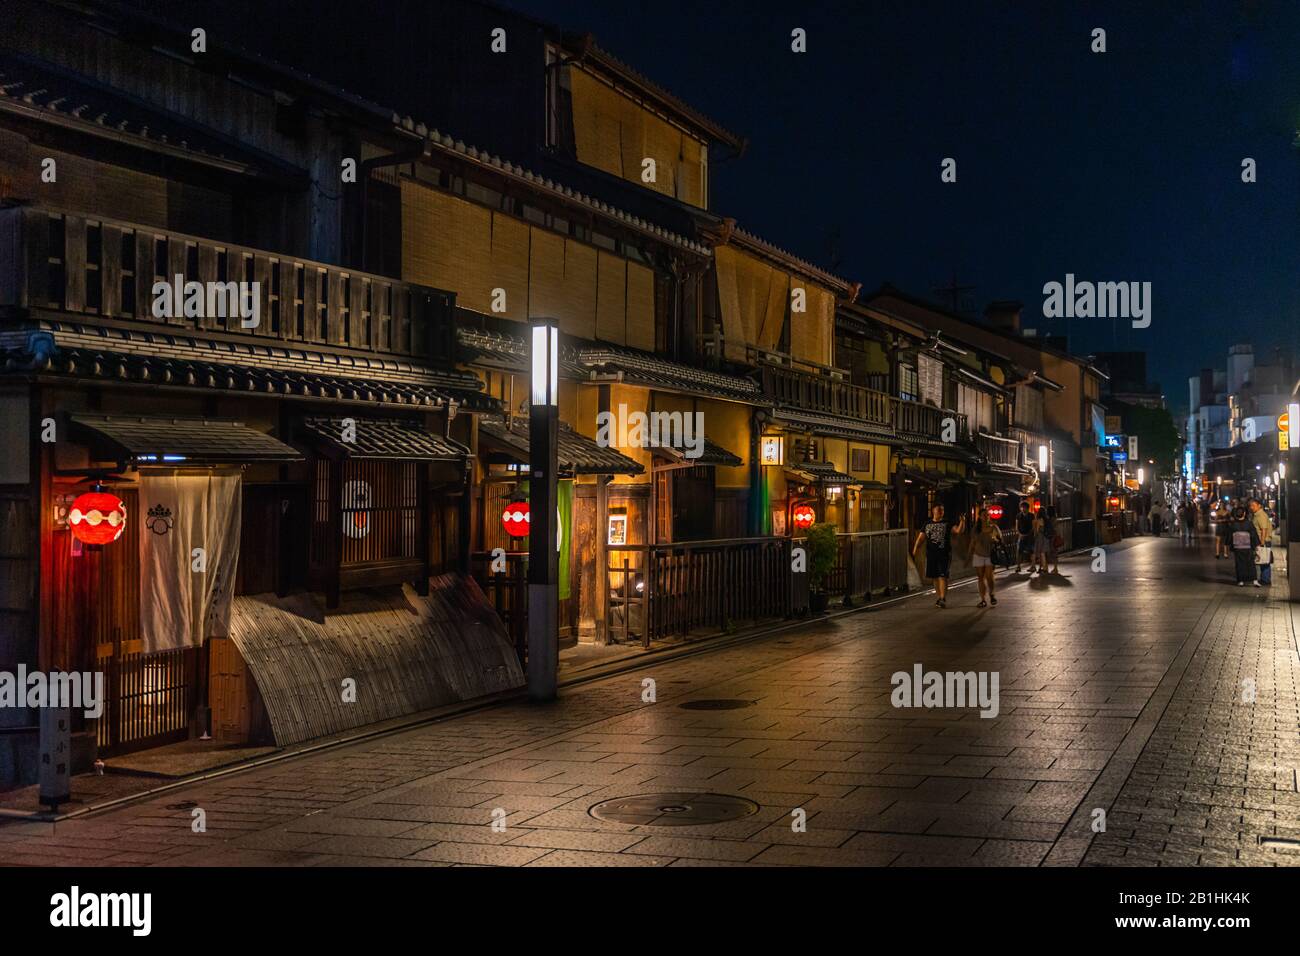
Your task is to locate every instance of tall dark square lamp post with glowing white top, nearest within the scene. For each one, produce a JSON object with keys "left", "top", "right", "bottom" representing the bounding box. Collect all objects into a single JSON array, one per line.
[{"left": 528, "top": 320, "right": 559, "bottom": 701}]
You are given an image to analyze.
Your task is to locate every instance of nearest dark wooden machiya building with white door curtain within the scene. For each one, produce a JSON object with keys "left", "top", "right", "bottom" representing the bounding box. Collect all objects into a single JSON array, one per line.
[{"left": 0, "top": 3, "right": 535, "bottom": 783}]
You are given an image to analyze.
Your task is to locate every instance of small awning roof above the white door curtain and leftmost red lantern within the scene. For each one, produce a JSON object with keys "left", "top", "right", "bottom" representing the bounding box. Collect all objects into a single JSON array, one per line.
[{"left": 70, "top": 415, "right": 302, "bottom": 464}]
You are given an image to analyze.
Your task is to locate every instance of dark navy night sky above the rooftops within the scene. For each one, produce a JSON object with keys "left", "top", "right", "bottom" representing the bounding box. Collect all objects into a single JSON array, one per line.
[{"left": 506, "top": 0, "right": 1300, "bottom": 406}]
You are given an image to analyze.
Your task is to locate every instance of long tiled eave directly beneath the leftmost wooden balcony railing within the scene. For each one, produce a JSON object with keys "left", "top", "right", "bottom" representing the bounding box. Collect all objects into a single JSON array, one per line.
[{"left": 0, "top": 333, "right": 501, "bottom": 411}]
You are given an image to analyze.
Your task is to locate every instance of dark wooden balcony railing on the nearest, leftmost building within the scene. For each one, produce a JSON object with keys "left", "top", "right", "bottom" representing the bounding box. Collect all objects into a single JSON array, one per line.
[{"left": 0, "top": 206, "right": 455, "bottom": 362}]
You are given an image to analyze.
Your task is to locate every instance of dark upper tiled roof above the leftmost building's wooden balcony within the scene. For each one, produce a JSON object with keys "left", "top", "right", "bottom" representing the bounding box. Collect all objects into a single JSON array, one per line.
[{"left": 0, "top": 49, "right": 306, "bottom": 179}]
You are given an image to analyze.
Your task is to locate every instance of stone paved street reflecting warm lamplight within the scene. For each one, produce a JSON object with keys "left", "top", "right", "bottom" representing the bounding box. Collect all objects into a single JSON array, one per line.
[{"left": 0, "top": 537, "right": 1300, "bottom": 866}]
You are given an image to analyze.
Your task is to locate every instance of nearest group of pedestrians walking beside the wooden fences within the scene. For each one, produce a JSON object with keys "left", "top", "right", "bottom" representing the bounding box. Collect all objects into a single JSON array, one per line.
[{"left": 911, "top": 501, "right": 1061, "bottom": 607}]
